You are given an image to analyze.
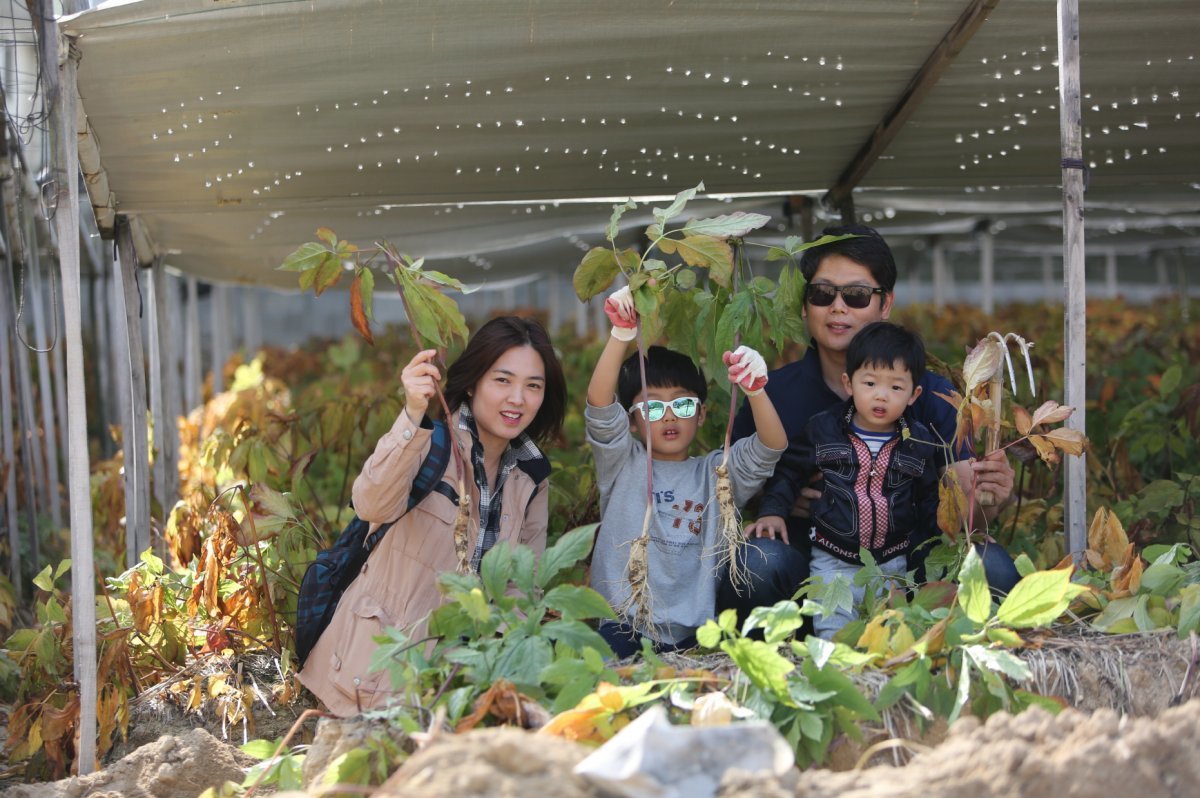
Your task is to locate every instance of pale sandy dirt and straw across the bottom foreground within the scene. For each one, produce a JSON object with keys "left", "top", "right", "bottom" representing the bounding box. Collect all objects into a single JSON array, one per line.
[{"left": 0, "top": 635, "right": 1200, "bottom": 798}]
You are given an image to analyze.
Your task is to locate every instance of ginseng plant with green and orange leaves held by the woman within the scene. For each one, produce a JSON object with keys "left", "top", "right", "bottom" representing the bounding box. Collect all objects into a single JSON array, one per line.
[{"left": 278, "top": 227, "right": 470, "bottom": 572}]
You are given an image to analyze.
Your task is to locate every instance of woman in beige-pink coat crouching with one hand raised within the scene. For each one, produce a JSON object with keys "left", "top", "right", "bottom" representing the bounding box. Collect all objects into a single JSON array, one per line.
[{"left": 300, "top": 316, "right": 566, "bottom": 715}]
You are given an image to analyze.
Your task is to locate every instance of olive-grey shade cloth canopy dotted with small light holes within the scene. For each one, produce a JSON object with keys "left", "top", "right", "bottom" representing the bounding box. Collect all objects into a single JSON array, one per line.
[{"left": 64, "top": 0, "right": 1200, "bottom": 286}]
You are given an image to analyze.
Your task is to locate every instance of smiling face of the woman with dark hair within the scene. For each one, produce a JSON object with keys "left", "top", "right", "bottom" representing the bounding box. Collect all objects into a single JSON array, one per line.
[{"left": 469, "top": 346, "right": 546, "bottom": 454}]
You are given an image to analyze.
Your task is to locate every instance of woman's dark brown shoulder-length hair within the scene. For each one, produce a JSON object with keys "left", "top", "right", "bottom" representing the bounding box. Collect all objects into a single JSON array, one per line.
[{"left": 445, "top": 316, "right": 566, "bottom": 443}]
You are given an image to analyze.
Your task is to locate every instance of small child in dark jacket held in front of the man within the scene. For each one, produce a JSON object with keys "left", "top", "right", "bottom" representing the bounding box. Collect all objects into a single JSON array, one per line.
[{"left": 773, "top": 322, "right": 938, "bottom": 638}]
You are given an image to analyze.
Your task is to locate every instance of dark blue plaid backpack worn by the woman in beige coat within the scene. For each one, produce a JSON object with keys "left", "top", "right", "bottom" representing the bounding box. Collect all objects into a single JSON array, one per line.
[{"left": 295, "top": 421, "right": 458, "bottom": 667}]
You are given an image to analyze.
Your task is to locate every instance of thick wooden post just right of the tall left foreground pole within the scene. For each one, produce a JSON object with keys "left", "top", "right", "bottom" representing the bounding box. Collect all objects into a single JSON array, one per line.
[{"left": 114, "top": 223, "right": 150, "bottom": 568}]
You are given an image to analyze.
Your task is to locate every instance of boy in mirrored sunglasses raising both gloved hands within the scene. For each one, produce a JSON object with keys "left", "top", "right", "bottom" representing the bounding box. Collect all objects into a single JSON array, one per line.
[{"left": 583, "top": 288, "right": 787, "bottom": 658}]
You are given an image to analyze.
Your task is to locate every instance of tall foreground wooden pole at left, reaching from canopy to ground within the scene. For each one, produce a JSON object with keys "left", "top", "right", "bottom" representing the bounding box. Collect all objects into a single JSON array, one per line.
[{"left": 40, "top": 14, "right": 97, "bottom": 775}]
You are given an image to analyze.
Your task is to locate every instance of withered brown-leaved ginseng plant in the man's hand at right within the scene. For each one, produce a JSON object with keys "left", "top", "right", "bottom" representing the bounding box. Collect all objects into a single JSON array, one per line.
[{"left": 937, "top": 332, "right": 1087, "bottom": 538}]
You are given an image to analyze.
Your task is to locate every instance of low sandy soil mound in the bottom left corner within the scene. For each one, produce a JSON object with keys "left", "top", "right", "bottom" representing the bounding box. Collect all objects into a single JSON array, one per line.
[{"left": 0, "top": 728, "right": 253, "bottom": 798}]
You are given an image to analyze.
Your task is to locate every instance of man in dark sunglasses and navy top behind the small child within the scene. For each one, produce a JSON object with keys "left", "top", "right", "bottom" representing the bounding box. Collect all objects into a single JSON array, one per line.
[{"left": 718, "top": 224, "right": 1020, "bottom": 617}]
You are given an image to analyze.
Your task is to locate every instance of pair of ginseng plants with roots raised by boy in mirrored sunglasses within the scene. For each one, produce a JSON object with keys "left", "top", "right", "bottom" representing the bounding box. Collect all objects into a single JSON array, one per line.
[{"left": 574, "top": 184, "right": 846, "bottom": 630}]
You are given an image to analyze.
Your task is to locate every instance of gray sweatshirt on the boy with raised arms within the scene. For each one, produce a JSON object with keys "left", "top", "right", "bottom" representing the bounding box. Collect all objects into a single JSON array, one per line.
[{"left": 583, "top": 402, "right": 782, "bottom": 643}]
